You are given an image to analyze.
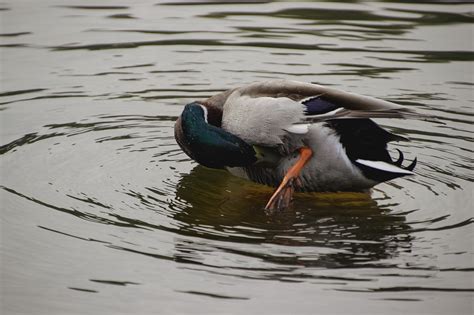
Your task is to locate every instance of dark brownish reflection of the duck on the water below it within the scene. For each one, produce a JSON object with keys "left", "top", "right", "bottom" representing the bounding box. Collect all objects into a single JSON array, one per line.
[{"left": 169, "top": 166, "right": 411, "bottom": 268}]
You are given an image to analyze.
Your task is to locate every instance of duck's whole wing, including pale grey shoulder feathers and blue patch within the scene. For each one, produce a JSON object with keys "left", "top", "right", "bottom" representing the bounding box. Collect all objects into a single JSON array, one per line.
[{"left": 213, "top": 80, "right": 421, "bottom": 146}]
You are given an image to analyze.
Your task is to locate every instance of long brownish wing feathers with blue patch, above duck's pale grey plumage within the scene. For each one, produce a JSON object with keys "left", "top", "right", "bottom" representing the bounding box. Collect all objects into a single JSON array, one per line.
[{"left": 237, "top": 80, "right": 424, "bottom": 122}]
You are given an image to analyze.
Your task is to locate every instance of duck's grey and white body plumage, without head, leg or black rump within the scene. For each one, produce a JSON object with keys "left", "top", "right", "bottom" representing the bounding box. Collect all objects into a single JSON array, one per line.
[{"left": 193, "top": 80, "right": 422, "bottom": 191}]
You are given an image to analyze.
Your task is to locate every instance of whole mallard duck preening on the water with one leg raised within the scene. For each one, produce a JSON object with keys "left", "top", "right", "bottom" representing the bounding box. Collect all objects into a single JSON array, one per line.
[{"left": 174, "top": 79, "right": 423, "bottom": 212}]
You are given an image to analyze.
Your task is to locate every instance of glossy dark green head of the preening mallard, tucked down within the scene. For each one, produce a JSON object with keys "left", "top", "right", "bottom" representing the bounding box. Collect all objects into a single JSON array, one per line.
[{"left": 174, "top": 102, "right": 257, "bottom": 168}]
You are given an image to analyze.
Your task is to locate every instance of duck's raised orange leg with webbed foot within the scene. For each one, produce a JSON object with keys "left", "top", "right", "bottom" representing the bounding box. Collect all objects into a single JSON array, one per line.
[{"left": 265, "top": 147, "right": 313, "bottom": 211}]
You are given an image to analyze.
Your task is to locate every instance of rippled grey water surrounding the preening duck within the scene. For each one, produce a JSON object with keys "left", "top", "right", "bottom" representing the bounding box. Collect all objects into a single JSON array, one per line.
[{"left": 0, "top": 0, "right": 474, "bottom": 314}]
